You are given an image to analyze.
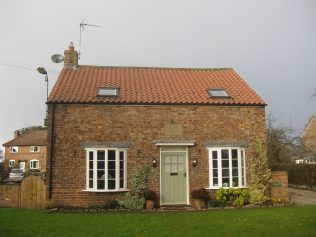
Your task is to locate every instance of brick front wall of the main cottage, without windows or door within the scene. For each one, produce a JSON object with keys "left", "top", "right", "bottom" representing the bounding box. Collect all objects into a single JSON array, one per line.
[{"left": 47, "top": 104, "right": 265, "bottom": 206}]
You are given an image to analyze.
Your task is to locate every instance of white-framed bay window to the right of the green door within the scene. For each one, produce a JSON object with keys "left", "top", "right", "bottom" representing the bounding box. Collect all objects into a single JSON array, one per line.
[{"left": 208, "top": 147, "right": 246, "bottom": 189}]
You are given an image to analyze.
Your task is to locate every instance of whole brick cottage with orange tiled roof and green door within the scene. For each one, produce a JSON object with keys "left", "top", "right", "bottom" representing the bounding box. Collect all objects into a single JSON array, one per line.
[{"left": 47, "top": 44, "right": 266, "bottom": 206}]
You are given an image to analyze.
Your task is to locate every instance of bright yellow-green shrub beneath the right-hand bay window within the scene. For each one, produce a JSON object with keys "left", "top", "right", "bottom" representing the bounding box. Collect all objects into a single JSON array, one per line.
[{"left": 216, "top": 188, "right": 250, "bottom": 207}]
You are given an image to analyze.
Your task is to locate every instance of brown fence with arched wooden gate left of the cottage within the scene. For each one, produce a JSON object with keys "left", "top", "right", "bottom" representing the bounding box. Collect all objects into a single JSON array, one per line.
[{"left": 0, "top": 176, "right": 46, "bottom": 209}]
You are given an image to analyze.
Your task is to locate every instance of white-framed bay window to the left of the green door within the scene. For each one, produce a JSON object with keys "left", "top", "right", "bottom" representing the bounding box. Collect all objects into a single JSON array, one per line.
[{"left": 86, "top": 148, "right": 127, "bottom": 192}]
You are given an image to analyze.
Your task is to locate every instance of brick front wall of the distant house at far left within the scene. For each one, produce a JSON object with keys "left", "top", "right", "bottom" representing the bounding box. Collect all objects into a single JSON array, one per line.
[{"left": 4, "top": 146, "right": 47, "bottom": 171}]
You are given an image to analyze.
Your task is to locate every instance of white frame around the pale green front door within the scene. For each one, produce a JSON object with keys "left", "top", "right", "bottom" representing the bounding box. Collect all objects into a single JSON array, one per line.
[{"left": 159, "top": 144, "right": 190, "bottom": 206}]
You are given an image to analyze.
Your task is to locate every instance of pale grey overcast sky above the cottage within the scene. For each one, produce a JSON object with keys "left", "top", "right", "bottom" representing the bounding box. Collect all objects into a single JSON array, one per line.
[{"left": 0, "top": 0, "right": 316, "bottom": 150}]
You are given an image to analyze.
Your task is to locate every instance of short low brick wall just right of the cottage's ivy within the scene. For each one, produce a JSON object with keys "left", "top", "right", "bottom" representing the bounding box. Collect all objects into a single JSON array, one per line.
[{"left": 269, "top": 171, "right": 289, "bottom": 200}]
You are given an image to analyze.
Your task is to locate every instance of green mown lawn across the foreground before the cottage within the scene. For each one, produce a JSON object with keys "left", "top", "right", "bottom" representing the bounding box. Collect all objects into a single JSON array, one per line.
[{"left": 0, "top": 206, "right": 316, "bottom": 237}]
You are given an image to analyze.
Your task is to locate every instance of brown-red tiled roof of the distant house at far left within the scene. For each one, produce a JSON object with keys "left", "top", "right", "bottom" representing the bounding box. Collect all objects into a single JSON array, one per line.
[{"left": 3, "top": 130, "right": 47, "bottom": 147}]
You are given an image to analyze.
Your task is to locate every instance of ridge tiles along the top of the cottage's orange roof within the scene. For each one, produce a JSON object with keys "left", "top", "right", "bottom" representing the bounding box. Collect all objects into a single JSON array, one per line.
[{"left": 78, "top": 65, "right": 234, "bottom": 71}]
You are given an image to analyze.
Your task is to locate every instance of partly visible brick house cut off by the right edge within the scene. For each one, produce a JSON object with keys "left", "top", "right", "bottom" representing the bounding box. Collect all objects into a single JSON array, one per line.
[{"left": 300, "top": 114, "right": 316, "bottom": 164}]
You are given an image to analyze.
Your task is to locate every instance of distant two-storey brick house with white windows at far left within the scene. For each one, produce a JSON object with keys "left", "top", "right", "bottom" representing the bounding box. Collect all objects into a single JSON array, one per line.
[{"left": 3, "top": 130, "right": 47, "bottom": 171}]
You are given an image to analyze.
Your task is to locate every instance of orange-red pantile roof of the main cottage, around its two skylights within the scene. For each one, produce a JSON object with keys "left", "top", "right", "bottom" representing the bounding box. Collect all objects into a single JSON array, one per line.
[{"left": 49, "top": 66, "right": 265, "bottom": 105}]
